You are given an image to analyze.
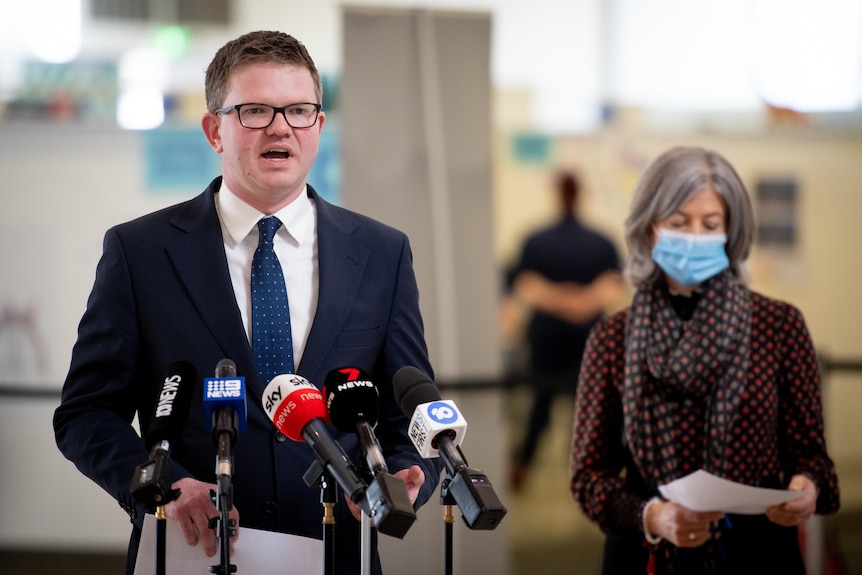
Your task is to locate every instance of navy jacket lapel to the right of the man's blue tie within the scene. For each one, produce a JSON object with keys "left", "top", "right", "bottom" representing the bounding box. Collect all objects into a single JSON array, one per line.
[{"left": 297, "top": 186, "right": 371, "bottom": 385}]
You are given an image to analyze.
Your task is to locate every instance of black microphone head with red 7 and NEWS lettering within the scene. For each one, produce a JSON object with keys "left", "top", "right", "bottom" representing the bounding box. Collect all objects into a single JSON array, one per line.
[{"left": 323, "top": 367, "right": 380, "bottom": 433}]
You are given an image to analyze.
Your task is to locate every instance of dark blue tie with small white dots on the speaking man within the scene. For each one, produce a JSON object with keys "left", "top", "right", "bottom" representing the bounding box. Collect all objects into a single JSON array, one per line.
[{"left": 251, "top": 217, "right": 293, "bottom": 385}]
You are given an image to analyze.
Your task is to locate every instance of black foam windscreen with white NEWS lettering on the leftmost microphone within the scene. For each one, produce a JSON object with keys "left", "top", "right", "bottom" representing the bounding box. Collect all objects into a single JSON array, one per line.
[{"left": 144, "top": 361, "right": 198, "bottom": 450}]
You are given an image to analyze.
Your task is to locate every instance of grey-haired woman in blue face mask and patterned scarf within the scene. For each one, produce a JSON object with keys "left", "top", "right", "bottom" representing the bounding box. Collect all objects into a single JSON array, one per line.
[{"left": 571, "top": 147, "right": 839, "bottom": 575}]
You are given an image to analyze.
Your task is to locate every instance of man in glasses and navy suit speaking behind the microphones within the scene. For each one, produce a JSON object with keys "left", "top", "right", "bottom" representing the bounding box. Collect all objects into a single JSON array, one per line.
[{"left": 54, "top": 32, "right": 440, "bottom": 574}]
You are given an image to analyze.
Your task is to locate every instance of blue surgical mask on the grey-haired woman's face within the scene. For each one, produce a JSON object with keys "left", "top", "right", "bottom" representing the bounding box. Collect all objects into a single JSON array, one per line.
[{"left": 652, "top": 228, "right": 730, "bottom": 287}]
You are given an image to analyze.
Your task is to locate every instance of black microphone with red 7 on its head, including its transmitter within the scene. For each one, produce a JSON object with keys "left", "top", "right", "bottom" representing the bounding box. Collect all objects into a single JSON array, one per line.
[{"left": 323, "top": 367, "right": 416, "bottom": 539}]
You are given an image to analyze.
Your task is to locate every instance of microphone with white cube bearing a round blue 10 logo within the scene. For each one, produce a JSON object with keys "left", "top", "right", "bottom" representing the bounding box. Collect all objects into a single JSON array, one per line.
[{"left": 392, "top": 366, "right": 506, "bottom": 530}]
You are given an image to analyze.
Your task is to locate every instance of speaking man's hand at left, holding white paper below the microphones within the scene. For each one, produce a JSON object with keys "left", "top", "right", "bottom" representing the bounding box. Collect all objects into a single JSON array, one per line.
[{"left": 165, "top": 477, "right": 239, "bottom": 557}]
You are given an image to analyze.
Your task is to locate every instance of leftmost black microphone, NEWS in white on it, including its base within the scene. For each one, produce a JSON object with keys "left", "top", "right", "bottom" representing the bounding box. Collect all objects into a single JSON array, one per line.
[{"left": 130, "top": 361, "right": 197, "bottom": 510}]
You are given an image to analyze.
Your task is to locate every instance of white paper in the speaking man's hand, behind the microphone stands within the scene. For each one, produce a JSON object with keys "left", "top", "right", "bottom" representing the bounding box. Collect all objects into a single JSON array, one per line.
[{"left": 135, "top": 514, "right": 323, "bottom": 575}]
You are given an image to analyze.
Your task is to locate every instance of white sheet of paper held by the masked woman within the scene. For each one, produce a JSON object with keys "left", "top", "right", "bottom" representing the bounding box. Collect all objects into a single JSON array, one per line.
[{"left": 658, "top": 469, "right": 814, "bottom": 515}]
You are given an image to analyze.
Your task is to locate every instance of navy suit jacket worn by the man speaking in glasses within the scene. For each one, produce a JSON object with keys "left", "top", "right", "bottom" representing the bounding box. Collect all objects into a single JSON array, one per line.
[{"left": 54, "top": 178, "right": 441, "bottom": 573}]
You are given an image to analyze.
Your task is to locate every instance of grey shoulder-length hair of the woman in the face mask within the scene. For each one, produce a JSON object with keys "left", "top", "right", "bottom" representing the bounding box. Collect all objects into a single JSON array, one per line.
[{"left": 625, "top": 146, "right": 755, "bottom": 287}]
